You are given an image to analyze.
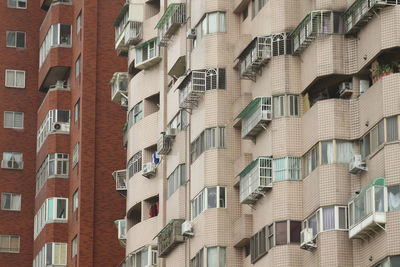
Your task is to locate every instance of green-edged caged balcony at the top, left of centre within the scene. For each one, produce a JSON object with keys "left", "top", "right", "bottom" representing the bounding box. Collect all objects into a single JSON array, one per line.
[{"left": 156, "top": 4, "right": 186, "bottom": 46}]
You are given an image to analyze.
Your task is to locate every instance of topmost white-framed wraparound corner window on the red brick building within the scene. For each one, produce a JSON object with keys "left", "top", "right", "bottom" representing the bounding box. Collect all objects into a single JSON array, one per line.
[{"left": 39, "top": 23, "right": 72, "bottom": 67}]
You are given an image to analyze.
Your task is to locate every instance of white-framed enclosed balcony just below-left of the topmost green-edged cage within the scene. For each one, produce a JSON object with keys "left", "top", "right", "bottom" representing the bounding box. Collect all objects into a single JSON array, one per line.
[{"left": 135, "top": 38, "right": 161, "bottom": 70}]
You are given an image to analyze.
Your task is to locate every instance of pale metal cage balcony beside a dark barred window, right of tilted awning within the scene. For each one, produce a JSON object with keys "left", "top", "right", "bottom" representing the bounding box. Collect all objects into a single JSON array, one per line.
[{"left": 178, "top": 70, "right": 206, "bottom": 109}]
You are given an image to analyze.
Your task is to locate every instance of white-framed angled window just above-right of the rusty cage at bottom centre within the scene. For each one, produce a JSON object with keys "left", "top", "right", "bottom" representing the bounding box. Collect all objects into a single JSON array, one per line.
[{"left": 191, "top": 186, "right": 226, "bottom": 219}]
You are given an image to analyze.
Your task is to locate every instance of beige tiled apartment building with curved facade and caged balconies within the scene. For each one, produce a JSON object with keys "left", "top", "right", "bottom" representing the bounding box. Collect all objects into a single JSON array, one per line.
[{"left": 110, "top": 0, "right": 400, "bottom": 267}]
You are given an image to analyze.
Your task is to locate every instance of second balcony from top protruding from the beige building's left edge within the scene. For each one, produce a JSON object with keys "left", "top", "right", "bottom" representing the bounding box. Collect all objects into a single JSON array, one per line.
[{"left": 110, "top": 72, "right": 129, "bottom": 108}]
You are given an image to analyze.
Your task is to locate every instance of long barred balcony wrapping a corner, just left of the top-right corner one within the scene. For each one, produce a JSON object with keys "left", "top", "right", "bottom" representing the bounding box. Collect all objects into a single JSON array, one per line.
[{"left": 289, "top": 10, "right": 343, "bottom": 55}]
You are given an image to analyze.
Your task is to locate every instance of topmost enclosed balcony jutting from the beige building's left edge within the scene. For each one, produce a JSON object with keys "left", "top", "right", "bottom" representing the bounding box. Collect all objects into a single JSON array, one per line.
[{"left": 114, "top": 2, "right": 144, "bottom": 56}]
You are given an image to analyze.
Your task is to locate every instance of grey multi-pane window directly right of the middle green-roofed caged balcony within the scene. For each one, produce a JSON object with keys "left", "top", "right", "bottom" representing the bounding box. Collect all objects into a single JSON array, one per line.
[{"left": 273, "top": 95, "right": 299, "bottom": 118}]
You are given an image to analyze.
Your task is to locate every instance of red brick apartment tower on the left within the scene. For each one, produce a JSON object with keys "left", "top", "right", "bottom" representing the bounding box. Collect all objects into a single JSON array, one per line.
[{"left": 0, "top": 0, "right": 127, "bottom": 267}]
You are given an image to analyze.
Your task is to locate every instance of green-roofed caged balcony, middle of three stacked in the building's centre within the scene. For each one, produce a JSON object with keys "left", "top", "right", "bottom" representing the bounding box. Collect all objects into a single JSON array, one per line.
[{"left": 238, "top": 97, "right": 272, "bottom": 139}]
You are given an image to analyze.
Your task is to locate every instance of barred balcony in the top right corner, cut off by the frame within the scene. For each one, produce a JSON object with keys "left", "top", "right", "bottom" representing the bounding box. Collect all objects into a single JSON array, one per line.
[{"left": 343, "top": 0, "right": 400, "bottom": 34}]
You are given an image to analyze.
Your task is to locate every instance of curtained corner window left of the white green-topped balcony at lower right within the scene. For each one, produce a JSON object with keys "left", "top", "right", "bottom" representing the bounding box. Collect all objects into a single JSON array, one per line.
[{"left": 303, "top": 206, "right": 348, "bottom": 237}]
